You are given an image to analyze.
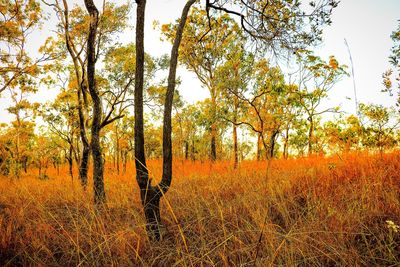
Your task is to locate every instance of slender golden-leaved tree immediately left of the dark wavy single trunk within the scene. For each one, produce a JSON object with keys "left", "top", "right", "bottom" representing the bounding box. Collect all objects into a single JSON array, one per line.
[{"left": 42, "top": 0, "right": 129, "bottom": 188}]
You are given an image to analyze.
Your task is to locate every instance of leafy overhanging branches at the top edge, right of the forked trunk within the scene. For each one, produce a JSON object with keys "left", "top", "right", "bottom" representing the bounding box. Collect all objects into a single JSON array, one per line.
[{"left": 204, "top": 0, "right": 339, "bottom": 56}]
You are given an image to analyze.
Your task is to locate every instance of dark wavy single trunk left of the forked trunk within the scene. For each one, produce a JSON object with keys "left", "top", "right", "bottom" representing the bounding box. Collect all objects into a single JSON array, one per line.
[{"left": 85, "top": 0, "right": 106, "bottom": 204}]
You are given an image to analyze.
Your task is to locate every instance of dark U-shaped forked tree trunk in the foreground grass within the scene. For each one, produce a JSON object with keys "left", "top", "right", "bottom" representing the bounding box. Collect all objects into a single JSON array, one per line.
[{"left": 135, "top": 0, "right": 195, "bottom": 240}]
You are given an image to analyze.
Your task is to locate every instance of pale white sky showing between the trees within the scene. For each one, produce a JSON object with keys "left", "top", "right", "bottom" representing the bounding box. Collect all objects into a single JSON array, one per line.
[{"left": 0, "top": 0, "right": 400, "bottom": 122}]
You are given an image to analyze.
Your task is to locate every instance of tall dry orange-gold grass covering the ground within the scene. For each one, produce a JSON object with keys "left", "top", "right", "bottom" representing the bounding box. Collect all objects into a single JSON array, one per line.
[{"left": 0, "top": 153, "right": 400, "bottom": 266}]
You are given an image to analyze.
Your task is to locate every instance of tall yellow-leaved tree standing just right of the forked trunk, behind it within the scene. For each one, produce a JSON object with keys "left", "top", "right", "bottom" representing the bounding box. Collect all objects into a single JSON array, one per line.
[{"left": 162, "top": 8, "right": 244, "bottom": 161}]
